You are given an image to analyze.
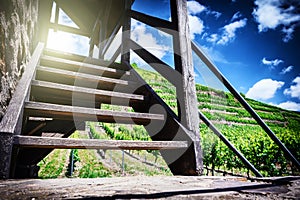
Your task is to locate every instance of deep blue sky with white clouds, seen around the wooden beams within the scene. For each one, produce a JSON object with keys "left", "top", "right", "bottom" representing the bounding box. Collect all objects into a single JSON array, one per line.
[{"left": 48, "top": 0, "right": 300, "bottom": 111}]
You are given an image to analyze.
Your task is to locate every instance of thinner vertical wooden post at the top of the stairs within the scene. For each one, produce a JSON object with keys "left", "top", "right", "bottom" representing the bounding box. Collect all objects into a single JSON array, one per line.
[{"left": 121, "top": 0, "right": 131, "bottom": 64}]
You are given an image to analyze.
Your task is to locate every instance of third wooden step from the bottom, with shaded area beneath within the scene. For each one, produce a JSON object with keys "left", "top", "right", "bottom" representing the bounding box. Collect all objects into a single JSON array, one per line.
[{"left": 31, "top": 80, "right": 145, "bottom": 106}]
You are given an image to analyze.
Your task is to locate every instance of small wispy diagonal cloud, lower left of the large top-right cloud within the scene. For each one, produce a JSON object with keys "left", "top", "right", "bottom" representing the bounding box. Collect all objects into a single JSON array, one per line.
[{"left": 217, "top": 18, "right": 247, "bottom": 45}]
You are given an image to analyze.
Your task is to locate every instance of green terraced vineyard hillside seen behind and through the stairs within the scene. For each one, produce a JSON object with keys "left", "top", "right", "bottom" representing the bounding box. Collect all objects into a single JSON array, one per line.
[{"left": 39, "top": 66, "right": 300, "bottom": 178}]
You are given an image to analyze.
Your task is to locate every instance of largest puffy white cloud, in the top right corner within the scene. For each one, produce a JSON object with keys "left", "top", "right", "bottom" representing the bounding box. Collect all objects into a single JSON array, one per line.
[{"left": 252, "top": 0, "right": 300, "bottom": 42}]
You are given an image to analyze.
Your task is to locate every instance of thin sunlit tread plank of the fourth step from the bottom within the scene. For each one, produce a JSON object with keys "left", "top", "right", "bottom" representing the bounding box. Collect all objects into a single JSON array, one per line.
[{"left": 37, "top": 66, "right": 136, "bottom": 86}]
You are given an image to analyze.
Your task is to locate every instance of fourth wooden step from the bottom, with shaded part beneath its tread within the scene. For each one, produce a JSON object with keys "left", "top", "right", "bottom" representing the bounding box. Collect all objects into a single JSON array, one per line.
[{"left": 36, "top": 66, "right": 136, "bottom": 90}]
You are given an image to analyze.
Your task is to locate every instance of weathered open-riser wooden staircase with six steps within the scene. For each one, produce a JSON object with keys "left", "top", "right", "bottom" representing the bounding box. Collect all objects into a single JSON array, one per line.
[{"left": 0, "top": 45, "right": 201, "bottom": 178}]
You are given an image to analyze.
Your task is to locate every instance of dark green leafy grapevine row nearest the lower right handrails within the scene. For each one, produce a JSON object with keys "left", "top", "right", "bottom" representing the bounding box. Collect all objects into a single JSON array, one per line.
[{"left": 200, "top": 125, "right": 300, "bottom": 176}]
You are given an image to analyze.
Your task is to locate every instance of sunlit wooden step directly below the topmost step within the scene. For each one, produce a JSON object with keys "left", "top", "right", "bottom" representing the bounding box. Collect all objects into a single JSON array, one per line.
[{"left": 40, "top": 56, "right": 130, "bottom": 78}]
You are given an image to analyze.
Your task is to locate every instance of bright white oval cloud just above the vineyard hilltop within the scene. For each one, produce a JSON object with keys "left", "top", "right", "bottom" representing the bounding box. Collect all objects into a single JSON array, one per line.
[{"left": 246, "top": 79, "right": 284, "bottom": 100}]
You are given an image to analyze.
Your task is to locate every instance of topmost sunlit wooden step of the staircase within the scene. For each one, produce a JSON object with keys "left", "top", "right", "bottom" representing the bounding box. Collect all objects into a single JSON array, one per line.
[{"left": 44, "top": 49, "right": 129, "bottom": 71}]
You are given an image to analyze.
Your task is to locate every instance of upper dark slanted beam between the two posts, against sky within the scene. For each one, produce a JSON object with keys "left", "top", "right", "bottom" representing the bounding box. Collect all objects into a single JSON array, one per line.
[{"left": 129, "top": 10, "right": 175, "bottom": 35}]
